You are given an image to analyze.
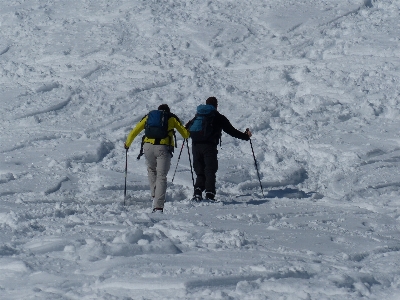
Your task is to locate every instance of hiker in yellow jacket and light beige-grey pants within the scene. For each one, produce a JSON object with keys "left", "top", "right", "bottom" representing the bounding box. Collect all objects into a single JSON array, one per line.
[{"left": 124, "top": 104, "right": 190, "bottom": 213}]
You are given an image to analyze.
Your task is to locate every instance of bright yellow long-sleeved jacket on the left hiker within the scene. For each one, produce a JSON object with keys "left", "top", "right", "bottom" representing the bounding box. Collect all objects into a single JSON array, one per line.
[{"left": 125, "top": 113, "right": 190, "bottom": 147}]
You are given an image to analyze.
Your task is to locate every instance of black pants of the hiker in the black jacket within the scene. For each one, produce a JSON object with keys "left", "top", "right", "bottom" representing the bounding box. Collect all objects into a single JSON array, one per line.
[{"left": 192, "top": 144, "right": 218, "bottom": 194}]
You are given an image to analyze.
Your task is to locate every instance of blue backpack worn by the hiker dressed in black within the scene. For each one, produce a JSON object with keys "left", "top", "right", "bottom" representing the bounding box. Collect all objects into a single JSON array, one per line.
[{"left": 189, "top": 104, "right": 218, "bottom": 143}]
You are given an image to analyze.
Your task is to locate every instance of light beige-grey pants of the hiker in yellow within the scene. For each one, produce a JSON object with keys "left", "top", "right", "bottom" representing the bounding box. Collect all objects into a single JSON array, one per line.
[{"left": 143, "top": 143, "right": 171, "bottom": 208}]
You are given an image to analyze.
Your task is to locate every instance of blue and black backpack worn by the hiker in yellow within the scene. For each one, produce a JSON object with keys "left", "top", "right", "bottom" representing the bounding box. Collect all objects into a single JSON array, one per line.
[{"left": 144, "top": 110, "right": 170, "bottom": 139}]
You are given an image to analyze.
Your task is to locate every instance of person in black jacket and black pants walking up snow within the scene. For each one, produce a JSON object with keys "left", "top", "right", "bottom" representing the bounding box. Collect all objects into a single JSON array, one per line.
[{"left": 186, "top": 97, "right": 251, "bottom": 201}]
